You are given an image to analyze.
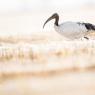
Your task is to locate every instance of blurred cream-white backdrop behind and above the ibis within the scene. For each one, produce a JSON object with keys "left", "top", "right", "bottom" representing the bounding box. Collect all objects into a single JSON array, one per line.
[{"left": 0, "top": 0, "right": 95, "bottom": 35}]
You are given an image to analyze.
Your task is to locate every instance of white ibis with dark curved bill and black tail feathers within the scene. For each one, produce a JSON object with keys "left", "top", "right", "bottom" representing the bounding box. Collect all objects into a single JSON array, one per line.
[{"left": 43, "top": 13, "right": 95, "bottom": 40}]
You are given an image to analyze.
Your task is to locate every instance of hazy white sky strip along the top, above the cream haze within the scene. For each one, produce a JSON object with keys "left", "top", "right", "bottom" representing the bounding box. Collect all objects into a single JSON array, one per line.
[{"left": 0, "top": 0, "right": 95, "bottom": 11}]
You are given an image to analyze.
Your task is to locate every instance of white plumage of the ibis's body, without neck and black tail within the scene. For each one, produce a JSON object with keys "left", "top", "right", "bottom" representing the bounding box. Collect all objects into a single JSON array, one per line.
[{"left": 54, "top": 22, "right": 87, "bottom": 39}]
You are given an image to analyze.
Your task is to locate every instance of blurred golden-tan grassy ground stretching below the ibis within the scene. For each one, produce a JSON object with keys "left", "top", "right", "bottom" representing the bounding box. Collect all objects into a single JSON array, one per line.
[{"left": 0, "top": 33, "right": 95, "bottom": 95}]
